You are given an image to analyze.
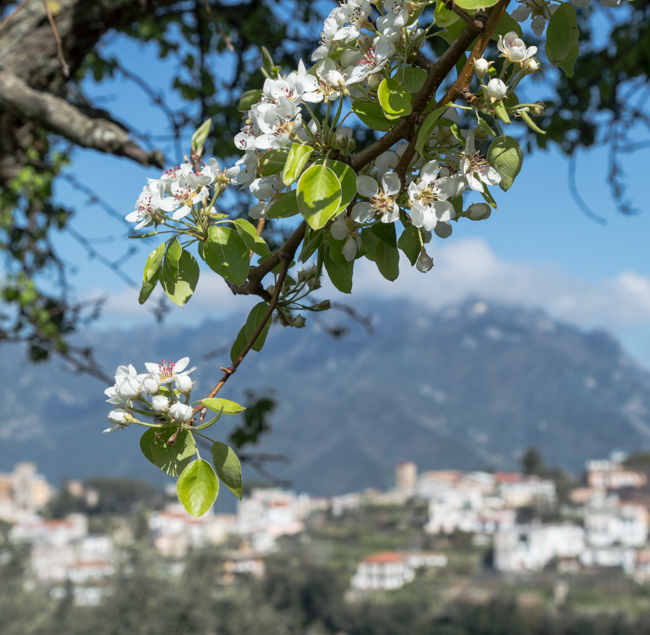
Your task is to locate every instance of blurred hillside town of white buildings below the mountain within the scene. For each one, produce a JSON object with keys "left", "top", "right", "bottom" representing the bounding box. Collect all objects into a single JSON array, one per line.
[{"left": 0, "top": 452, "right": 650, "bottom": 605}]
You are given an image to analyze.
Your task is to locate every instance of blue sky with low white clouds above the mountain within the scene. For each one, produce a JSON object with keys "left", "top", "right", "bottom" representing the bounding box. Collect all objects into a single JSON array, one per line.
[{"left": 48, "top": 9, "right": 650, "bottom": 368}]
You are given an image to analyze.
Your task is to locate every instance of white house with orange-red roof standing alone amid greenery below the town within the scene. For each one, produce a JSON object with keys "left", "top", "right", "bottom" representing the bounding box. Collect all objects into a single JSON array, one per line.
[{"left": 350, "top": 551, "right": 447, "bottom": 591}]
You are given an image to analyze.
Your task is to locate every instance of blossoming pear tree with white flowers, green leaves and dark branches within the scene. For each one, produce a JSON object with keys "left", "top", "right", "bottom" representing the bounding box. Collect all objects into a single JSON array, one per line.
[{"left": 0, "top": 0, "right": 636, "bottom": 516}]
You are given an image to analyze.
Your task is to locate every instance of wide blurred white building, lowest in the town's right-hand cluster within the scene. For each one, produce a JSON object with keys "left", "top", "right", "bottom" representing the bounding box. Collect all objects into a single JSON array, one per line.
[{"left": 493, "top": 525, "right": 585, "bottom": 571}]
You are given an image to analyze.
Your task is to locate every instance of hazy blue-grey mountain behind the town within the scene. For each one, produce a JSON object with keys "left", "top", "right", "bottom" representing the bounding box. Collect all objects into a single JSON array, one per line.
[{"left": 0, "top": 300, "right": 650, "bottom": 494}]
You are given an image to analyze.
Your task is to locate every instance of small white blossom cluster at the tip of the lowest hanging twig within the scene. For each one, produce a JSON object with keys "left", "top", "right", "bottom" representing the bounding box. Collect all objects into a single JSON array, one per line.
[{"left": 104, "top": 357, "right": 196, "bottom": 432}]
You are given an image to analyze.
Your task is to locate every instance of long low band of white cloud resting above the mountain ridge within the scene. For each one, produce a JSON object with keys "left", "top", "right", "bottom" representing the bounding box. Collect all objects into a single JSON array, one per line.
[{"left": 87, "top": 238, "right": 650, "bottom": 331}]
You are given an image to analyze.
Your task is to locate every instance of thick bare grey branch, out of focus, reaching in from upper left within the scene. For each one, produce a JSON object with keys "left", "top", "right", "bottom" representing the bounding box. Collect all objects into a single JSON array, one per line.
[{"left": 0, "top": 70, "right": 162, "bottom": 168}]
